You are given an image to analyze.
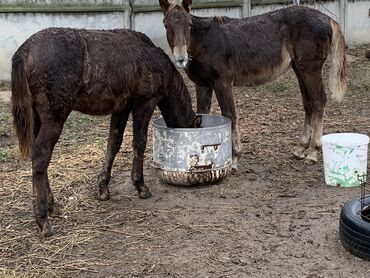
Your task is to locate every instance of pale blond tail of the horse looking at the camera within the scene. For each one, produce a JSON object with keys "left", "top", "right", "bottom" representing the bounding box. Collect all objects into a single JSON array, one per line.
[{"left": 329, "top": 20, "right": 347, "bottom": 101}]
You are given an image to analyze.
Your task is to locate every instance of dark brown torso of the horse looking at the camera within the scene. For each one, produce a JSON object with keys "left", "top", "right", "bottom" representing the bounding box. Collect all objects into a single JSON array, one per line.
[{"left": 188, "top": 6, "right": 332, "bottom": 86}]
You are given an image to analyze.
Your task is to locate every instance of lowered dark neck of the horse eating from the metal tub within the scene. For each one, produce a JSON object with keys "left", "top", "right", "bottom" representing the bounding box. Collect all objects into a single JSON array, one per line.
[{"left": 160, "top": 69, "right": 196, "bottom": 127}]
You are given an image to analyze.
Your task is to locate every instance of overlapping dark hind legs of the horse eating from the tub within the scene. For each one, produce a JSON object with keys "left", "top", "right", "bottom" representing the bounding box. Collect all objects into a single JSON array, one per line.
[{"left": 32, "top": 122, "right": 64, "bottom": 236}]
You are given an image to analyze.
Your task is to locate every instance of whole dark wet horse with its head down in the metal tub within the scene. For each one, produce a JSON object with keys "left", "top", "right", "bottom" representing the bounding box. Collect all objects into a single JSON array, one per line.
[{"left": 11, "top": 28, "right": 201, "bottom": 235}]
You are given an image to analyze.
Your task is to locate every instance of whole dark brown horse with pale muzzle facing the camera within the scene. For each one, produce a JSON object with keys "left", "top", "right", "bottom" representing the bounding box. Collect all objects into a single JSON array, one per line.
[{"left": 159, "top": 0, "right": 346, "bottom": 170}]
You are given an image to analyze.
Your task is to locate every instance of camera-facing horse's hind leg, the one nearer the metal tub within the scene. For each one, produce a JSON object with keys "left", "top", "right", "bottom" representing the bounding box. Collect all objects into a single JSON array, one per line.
[{"left": 292, "top": 63, "right": 312, "bottom": 159}]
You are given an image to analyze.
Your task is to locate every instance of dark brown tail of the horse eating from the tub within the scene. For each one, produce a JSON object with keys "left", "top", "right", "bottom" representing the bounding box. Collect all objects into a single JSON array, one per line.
[{"left": 11, "top": 45, "right": 34, "bottom": 159}]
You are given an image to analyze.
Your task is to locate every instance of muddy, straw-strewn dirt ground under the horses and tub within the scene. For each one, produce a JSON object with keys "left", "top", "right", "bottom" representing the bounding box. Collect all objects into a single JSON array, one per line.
[{"left": 0, "top": 45, "right": 370, "bottom": 278}]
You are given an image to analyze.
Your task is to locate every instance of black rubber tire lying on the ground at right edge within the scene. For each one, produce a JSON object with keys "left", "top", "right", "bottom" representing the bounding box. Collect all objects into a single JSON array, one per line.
[{"left": 339, "top": 196, "right": 370, "bottom": 261}]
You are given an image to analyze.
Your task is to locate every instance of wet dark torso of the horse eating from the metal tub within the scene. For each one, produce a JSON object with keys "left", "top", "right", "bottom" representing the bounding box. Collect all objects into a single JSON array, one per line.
[{"left": 19, "top": 28, "right": 176, "bottom": 114}]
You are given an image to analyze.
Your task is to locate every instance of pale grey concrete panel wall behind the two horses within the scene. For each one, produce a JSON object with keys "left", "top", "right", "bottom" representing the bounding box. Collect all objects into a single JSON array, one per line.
[{"left": 0, "top": 0, "right": 370, "bottom": 80}]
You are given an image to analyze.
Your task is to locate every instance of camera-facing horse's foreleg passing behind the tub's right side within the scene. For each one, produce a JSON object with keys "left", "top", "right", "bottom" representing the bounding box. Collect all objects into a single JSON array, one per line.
[{"left": 214, "top": 80, "right": 242, "bottom": 173}]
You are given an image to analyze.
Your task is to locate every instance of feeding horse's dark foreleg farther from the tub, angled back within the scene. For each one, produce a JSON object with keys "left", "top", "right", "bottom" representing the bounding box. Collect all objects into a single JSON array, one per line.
[{"left": 98, "top": 110, "right": 130, "bottom": 201}]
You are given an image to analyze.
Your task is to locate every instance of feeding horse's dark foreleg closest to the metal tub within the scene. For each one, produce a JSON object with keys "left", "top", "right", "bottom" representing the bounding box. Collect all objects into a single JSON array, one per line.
[{"left": 131, "top": 100, "right": 156, "bottom": 199}]
